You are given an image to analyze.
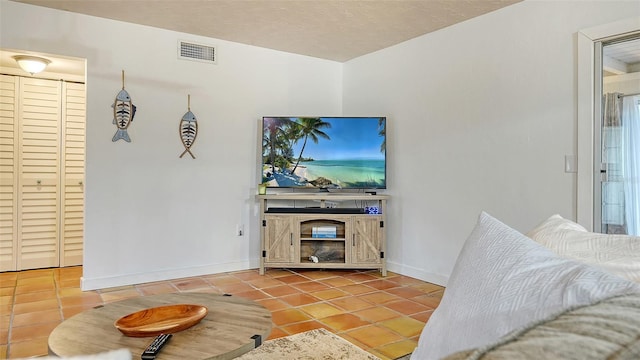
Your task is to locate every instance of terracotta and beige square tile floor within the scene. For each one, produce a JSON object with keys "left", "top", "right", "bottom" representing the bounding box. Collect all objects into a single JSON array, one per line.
[{"left": 0, "top": 267, "right": 444, "bottom": 360}]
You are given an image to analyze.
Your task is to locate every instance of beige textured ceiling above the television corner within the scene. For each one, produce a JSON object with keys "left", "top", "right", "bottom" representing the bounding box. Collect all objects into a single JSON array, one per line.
[{"left": 13, "top": 0, "right": 521, "bottom": 62}]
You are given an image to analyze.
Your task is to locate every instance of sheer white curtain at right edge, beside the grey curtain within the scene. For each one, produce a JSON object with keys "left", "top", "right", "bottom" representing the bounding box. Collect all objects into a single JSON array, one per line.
[{"left": 621, "top": 95, "right": 640, "bottom": 236}]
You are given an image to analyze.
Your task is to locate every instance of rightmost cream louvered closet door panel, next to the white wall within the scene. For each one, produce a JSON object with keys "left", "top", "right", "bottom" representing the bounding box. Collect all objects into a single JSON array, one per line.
[{"left": 60, "top": 83, "right": 85, "bottom": 266}]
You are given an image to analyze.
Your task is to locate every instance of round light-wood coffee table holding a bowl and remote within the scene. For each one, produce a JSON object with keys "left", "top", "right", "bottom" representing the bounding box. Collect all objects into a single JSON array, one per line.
[{"left": 49, "top": 293, "right": 272, "bottom": 360}]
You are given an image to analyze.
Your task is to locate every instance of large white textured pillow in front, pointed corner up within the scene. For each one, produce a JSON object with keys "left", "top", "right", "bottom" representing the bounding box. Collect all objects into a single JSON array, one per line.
[{"left": 411, "top": 212, "right": 640, "bottom": 360}]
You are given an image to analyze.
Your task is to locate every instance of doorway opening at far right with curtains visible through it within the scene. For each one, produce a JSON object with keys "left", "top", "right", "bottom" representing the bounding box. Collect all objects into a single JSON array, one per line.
[{"left": 594, "top": 34, "right": 640, "bottom": 235}]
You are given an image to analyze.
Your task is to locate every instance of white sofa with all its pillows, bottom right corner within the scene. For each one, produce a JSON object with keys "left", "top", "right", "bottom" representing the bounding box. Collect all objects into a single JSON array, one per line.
[{"left": 411, "top": 213, "right": 640, "bottom": 360}]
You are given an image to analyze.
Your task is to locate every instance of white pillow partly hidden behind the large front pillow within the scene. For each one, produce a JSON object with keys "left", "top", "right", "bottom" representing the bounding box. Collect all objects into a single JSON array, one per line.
[{"left": 527, "top": 215, "right": 640, "bottom": 283}]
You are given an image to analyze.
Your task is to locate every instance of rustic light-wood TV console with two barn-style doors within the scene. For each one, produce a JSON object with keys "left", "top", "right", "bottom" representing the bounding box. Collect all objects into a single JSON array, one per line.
[{"left": 256, "top": 193, "right": 389, "bottom": 276}]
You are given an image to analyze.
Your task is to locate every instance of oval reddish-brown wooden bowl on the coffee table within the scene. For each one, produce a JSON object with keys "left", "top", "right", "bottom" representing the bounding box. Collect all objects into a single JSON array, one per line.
[{"left": 114, "top": 304, "right": 208, "bottom": 337}]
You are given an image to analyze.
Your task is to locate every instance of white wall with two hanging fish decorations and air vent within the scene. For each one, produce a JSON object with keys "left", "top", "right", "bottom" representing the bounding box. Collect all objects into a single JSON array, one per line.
[{"left": 0, "top": 0, "right": 342, "bottom": 289}]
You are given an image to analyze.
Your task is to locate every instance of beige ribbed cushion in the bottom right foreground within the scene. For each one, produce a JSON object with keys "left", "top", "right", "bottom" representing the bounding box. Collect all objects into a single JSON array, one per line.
[{"left": 445, "top": 294, "right": 640, "bottom": 360}]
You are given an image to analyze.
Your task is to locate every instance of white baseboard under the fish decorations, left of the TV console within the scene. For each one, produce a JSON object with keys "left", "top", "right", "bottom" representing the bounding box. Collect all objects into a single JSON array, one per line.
[{"left": 80, "top": 261, "right": 257, "bottom": 291}]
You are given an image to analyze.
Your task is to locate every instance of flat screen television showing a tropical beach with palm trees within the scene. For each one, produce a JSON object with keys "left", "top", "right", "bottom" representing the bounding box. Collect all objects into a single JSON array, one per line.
[{"left": 261, "top": 116, "right": 387, "bottom": 190}]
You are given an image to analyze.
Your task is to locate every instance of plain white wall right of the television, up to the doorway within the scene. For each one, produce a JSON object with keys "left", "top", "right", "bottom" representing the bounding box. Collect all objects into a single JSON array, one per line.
[{"left": 344, "top": 1, "right": 640, "bottom": 284}]
